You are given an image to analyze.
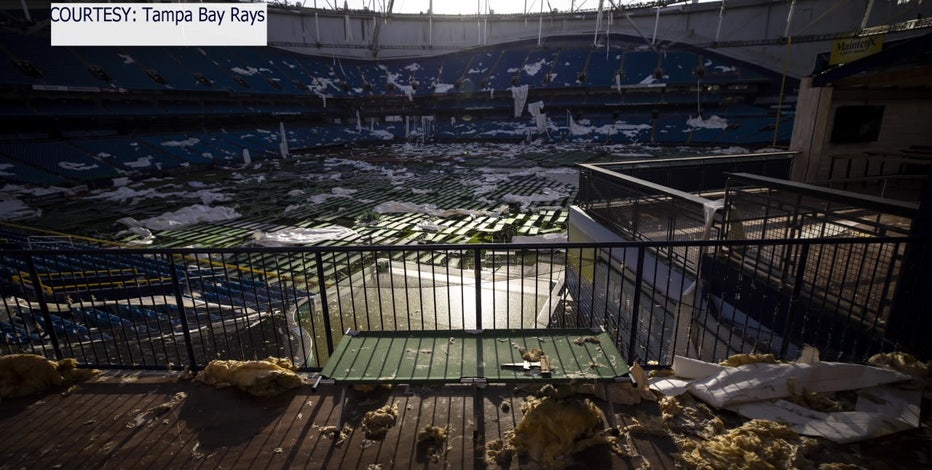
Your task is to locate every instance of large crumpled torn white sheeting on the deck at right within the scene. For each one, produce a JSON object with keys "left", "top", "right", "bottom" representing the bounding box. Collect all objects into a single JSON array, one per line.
[{"left": 651, "top": 353, "right": 922, "bottom": 444}]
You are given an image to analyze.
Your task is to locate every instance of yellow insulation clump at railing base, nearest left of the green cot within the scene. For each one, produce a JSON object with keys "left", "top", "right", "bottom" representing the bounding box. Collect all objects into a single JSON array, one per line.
[{"left": 195, "top": 357, "right": 302, "bottom": 397}]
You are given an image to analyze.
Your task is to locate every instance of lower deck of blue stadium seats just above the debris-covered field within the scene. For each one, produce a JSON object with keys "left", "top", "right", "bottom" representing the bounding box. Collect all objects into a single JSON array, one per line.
[{"left": 0, "top": 105, "right": 792, "bottom": 185}]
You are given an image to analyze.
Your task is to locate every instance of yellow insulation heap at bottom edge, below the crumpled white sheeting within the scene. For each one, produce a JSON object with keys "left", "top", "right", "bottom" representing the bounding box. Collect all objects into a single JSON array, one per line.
[{"left": 680, "top": 419, "right": 818, "bottom": 469}]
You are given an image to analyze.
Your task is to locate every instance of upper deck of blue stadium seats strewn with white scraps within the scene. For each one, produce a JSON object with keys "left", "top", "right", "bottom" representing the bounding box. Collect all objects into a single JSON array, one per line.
[{"left": 0, "top": 32, "right": 773, "bottom": 97}]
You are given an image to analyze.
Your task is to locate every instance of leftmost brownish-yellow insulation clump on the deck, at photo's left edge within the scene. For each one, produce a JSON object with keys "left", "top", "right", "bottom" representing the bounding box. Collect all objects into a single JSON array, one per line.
[{"left": 0, "top": 354, "right": 100, "bottom": 398}]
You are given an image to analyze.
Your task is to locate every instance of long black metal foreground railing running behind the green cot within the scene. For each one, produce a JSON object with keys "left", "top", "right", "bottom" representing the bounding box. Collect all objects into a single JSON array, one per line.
[{"left": 0, "top": 237, "right": 932, "bottom": 370}]
